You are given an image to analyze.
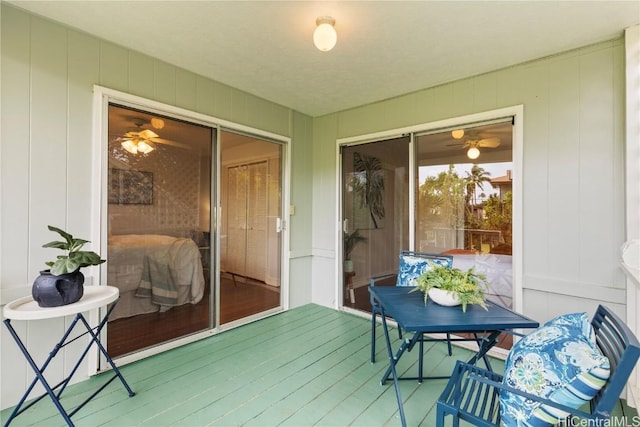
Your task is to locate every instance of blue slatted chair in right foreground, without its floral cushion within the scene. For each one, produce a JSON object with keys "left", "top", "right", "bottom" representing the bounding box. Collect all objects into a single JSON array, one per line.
[{"left": 436, "top": 305, "right": 640, "bottom": 427}]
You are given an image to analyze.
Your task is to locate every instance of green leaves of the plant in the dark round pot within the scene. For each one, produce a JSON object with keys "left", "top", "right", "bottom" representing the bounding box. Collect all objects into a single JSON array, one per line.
[{"left": 42, "top": 225, "right": 106, "bottom": 276}]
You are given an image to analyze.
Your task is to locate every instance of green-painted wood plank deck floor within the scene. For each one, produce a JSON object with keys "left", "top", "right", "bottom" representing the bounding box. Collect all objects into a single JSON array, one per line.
[{"left": 0, "top": 304, "right": 636, "bottom": 427}]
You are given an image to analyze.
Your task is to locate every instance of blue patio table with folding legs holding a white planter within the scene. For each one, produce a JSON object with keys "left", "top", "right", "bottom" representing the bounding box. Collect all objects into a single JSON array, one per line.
[{"left": 369, "top": 286, "right": 539, "bottom": 426}]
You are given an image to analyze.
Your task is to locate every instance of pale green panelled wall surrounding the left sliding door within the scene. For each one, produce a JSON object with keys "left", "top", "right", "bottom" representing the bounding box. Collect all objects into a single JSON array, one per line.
[{"left": 0, "top": 3, "right": 313, "bottom": 408}]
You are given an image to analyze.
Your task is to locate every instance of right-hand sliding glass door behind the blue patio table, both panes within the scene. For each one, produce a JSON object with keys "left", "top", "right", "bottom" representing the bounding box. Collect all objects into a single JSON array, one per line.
[{"left": 341, "top": 117, "right": 513, "bottom": 311}]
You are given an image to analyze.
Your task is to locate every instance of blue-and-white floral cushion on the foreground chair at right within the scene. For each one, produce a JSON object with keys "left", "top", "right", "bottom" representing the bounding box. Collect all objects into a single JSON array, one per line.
[{"left": 500, "top": 313, "right": 609, "bottom": 427}]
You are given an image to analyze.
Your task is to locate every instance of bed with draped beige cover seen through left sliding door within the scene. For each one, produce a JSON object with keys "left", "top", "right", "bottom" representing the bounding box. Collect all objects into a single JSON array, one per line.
[{"left": 107, "top": 234, "right": 205, "bottom": 320}]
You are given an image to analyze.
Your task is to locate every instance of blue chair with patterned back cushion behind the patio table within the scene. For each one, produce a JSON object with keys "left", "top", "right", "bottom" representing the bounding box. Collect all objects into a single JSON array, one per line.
[{"left": 369, "top": 250, "right": 453, "bottom": 363}]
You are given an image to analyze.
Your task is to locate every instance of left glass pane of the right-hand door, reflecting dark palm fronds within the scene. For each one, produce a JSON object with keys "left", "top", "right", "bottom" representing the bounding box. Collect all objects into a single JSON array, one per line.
[{"left": 341, "top": 137, "right": 409, "bottom": 311}]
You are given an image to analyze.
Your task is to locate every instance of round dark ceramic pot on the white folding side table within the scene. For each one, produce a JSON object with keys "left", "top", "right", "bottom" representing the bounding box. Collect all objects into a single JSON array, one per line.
[{"left": 31, "top": 270, "right": 84, "bottom": 307}]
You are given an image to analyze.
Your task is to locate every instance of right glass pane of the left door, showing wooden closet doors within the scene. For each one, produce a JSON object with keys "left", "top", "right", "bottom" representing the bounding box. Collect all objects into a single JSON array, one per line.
[{"left": 218, "top": 131, "right": 282, "bottom": 324}]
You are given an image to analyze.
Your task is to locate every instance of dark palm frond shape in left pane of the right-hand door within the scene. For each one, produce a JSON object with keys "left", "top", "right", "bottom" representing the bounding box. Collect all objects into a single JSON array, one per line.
[{"left": 353, "top": 153, "right": 384, "bottom": 228}]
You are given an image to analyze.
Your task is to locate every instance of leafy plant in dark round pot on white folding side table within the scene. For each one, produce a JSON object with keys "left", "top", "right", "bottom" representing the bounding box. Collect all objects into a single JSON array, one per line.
[{"left": 31, "top": 225, "right": 105, "bottom": 307}]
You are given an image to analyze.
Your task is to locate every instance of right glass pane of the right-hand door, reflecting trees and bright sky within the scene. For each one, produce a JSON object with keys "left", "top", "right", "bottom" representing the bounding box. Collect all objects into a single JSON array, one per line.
[{"left": 415, "top": 118, "right": 513, "bottom": 308}]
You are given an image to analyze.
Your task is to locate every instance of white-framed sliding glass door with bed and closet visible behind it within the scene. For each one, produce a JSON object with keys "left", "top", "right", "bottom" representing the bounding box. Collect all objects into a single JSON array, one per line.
[{"left": 96, "top": 88, "right": 288, "bottom": 361}]
